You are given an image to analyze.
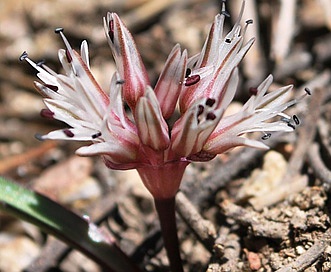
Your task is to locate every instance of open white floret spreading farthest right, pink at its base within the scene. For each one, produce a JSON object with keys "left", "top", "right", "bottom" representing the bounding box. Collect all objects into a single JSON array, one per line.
[{"left": 203, "top": 76, "right": 296, "bottom": 154}]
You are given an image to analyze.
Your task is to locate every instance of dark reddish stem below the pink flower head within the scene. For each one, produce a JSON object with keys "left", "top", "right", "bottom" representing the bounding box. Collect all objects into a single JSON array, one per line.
[{"left": 154, "top": 197, "right": 184, "bottom": 272}]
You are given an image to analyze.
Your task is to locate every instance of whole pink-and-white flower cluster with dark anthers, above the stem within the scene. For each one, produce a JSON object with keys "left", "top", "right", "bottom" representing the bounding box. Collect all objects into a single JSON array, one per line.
[{"left": 21, "top": 3, "right": 295, "bottom": 199}]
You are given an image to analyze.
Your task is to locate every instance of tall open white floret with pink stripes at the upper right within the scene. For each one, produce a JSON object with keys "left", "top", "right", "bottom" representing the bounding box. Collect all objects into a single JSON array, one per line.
[{"left": 179, "top": 2, "right": 254, "bottom": 113}]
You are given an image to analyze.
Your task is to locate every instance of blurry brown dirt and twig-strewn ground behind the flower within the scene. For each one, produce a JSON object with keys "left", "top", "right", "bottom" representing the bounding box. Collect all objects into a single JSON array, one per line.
[{"left": 0, "top": 0, "right": 331, "bottom": 272}]
